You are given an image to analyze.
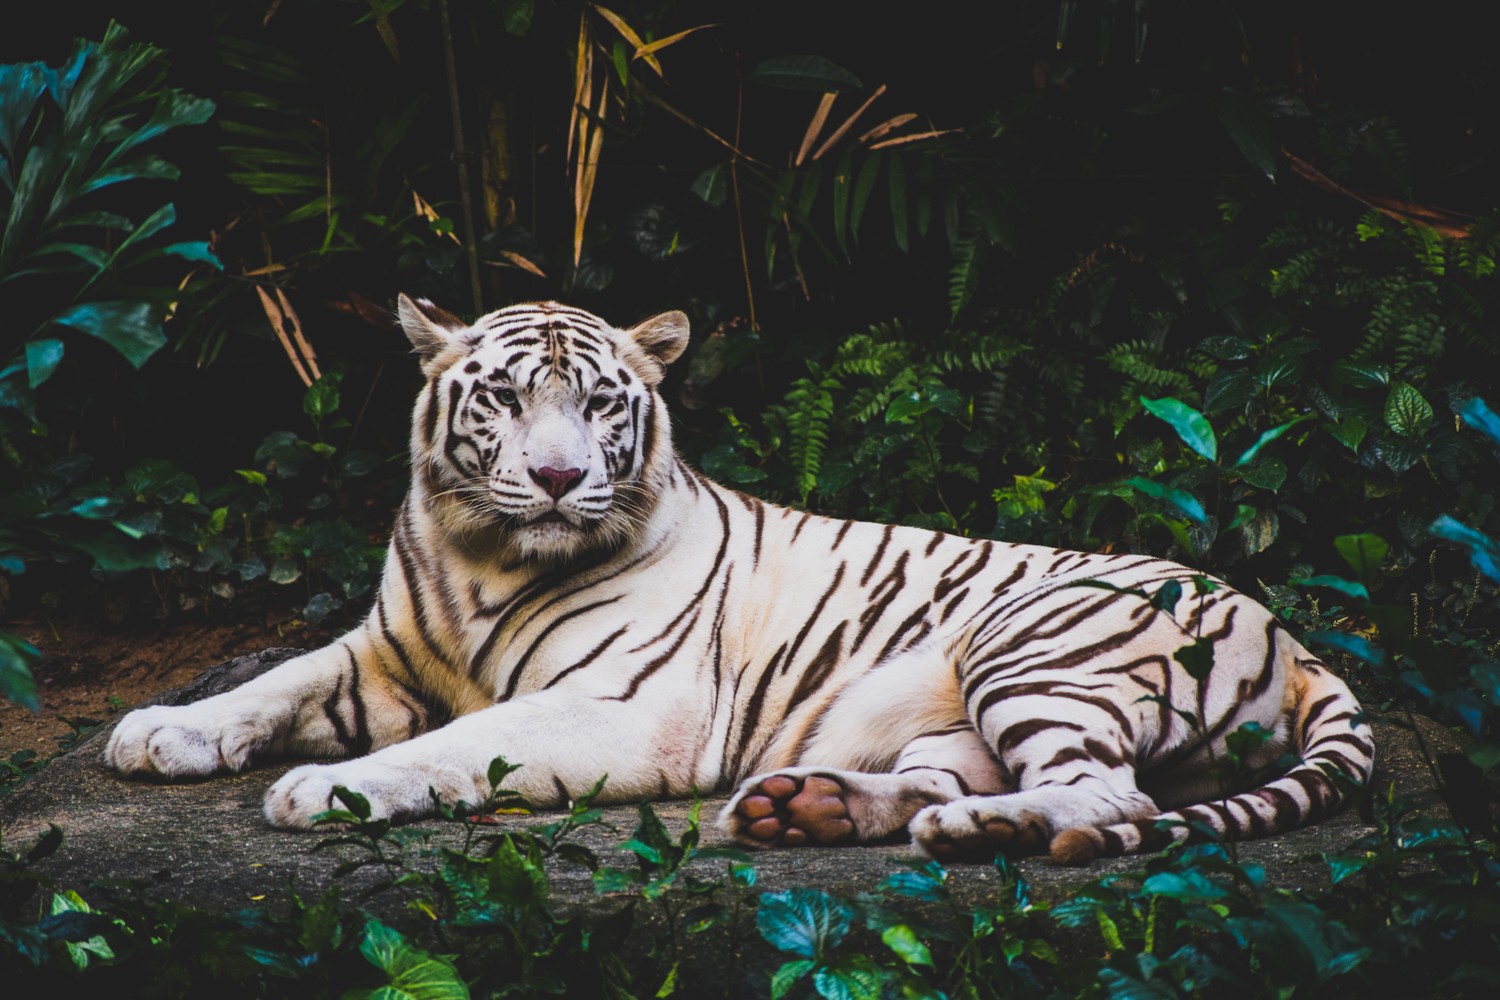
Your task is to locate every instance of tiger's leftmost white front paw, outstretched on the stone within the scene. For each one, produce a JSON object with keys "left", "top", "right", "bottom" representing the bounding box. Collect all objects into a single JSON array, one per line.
[{"left": 104, "top": 703, "right": 275, "bottom": 778}]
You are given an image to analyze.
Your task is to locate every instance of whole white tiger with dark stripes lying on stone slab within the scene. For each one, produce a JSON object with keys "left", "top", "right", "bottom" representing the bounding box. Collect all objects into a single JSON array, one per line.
[{"left": 105, "top": 295, "right": 1374, "bottom": 864}]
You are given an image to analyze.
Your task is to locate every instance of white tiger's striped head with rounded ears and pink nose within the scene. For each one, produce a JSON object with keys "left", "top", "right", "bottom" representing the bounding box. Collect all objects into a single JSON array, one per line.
[{"left": 398, "top": 295, "right": 687, "bottom": 561}]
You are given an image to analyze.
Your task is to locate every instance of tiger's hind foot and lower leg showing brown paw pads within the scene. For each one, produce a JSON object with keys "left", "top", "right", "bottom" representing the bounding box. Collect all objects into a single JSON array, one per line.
[{"left": 720, "top": 720, "right": 1005, "bottom": 847}]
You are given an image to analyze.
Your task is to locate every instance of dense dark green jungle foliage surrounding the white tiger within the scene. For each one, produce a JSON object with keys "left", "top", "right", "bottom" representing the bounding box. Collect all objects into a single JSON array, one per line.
[{"left": 0, "top": 0, "right": 1500, "bottom": 996}]
